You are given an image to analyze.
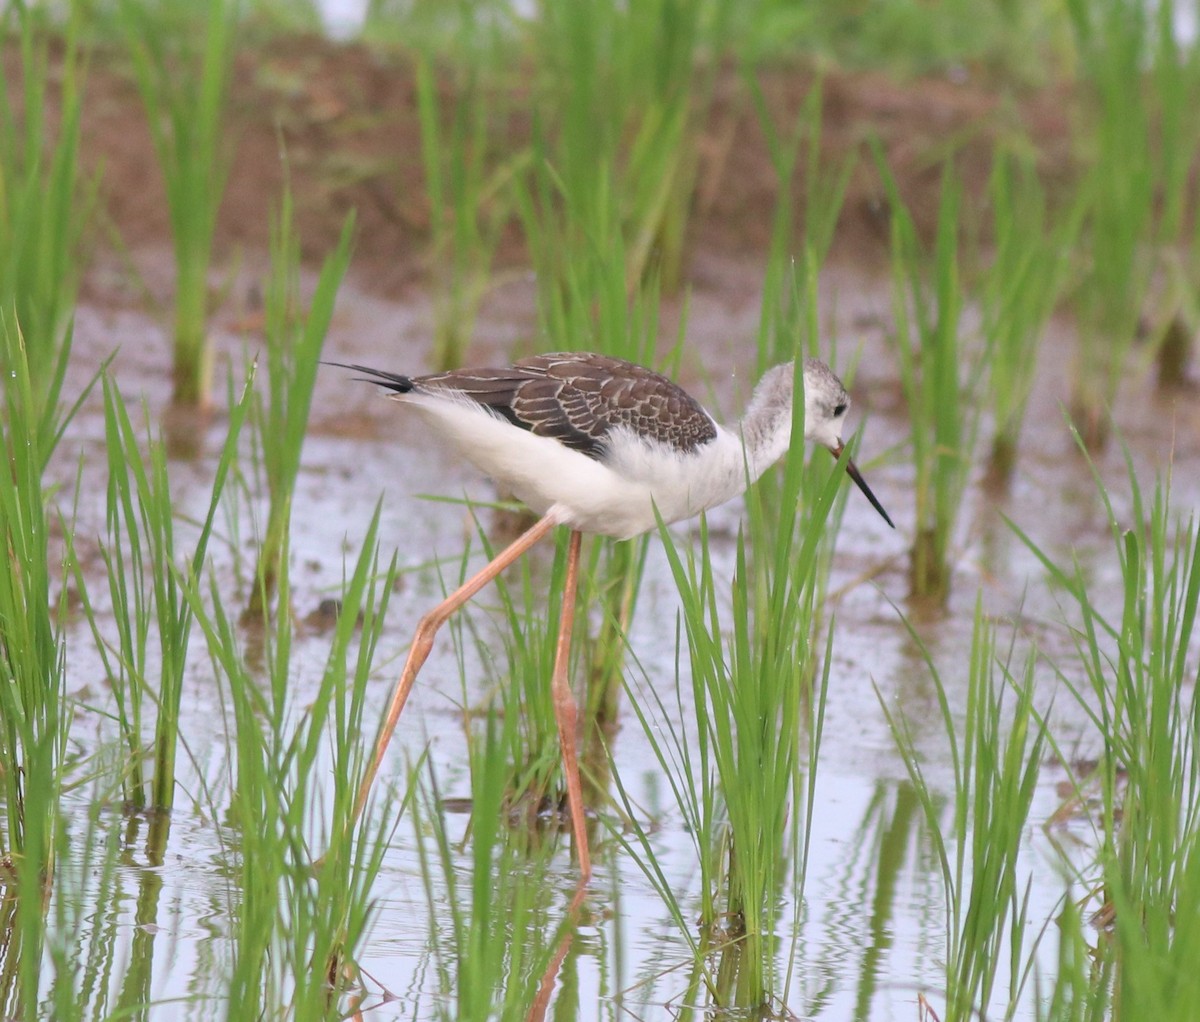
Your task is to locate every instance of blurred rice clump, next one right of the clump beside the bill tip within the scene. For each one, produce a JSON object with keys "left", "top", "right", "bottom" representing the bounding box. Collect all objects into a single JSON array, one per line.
[{"left": 978, "top": 154, "right": 1086, "bottom": 488}]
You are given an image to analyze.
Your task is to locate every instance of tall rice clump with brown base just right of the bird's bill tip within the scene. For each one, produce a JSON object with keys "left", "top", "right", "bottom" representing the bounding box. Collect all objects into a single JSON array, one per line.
[{"left": 875, "top": 154, "right": 988, "bottom": 605}]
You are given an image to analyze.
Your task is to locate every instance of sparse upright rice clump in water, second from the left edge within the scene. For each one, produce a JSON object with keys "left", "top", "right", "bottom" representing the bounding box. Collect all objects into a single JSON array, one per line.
[{"left": 76, "top": 373, "right": 253, "bottom": 820}]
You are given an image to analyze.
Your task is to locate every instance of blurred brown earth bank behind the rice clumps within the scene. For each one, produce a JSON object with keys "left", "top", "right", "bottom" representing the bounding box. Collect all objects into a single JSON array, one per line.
[{"left": 21, "top": 31, "right": 1070, "bottom": 295}]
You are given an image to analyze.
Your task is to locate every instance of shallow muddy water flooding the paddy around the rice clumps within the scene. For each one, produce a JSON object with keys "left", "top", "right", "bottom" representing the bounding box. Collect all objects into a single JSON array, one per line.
[{"left": 54, "top": 249, "right": 1200, "bottom": 1022}]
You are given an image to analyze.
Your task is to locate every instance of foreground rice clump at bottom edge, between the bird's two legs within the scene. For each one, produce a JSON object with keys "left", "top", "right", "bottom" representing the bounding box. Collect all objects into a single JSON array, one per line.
[{"left": 414, "top": 713, "right": 566, "bottom": 1022}]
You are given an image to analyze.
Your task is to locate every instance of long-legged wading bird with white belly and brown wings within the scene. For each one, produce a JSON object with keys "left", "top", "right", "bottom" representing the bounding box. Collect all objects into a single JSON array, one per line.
[{"left": 328, "top": 351, "right": 895, "bottom": 882}]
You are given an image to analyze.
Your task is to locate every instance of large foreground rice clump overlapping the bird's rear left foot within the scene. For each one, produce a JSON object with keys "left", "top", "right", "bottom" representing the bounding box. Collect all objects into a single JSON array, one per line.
[{"left": 188, "top": 507, "right": 396, "bottom": 1020}]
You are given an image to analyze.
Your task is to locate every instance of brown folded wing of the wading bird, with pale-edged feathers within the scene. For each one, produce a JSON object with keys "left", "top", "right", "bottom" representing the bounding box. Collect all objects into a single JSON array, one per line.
[{"left": 412, "top": 353, "right": 716, "bottom": 459}]
